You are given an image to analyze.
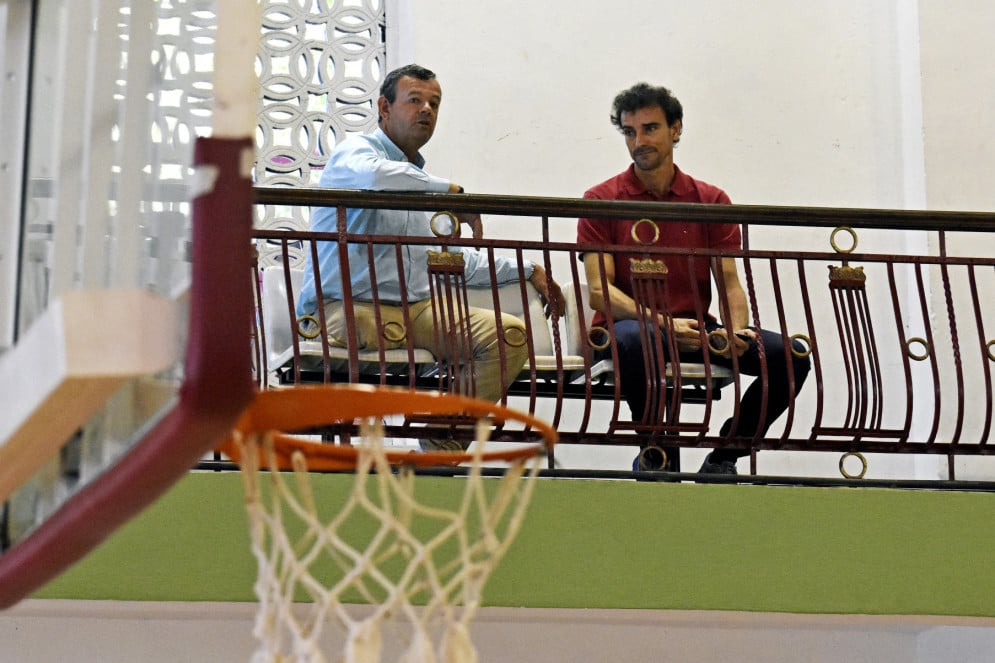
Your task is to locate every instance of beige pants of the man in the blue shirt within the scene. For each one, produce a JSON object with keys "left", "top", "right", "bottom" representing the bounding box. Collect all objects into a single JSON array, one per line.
[{"left": 325, "top": 299, "right": 529, "bottom": 402}]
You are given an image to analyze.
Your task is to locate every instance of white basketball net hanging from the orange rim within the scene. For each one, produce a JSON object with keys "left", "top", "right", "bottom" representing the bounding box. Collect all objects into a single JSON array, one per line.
[{"left": 237, "top": 421, "right": 539, "bottom": 663}]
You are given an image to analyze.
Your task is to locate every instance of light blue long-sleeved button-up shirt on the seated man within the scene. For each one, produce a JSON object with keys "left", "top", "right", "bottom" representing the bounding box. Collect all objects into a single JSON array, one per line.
[{"left": 297, "top": 129, "right": 533, "bottom": 315}]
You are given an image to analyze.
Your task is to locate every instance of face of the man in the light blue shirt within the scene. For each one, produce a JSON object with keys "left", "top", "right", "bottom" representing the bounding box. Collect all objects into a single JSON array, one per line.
[{"left": 378, "top": 76, "right": 442, "bottom": 157}]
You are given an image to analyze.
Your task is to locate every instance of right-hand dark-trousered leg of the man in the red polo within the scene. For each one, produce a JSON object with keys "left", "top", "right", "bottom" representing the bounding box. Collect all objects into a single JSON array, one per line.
[{"left": 703, "top": 329, "right": 811, "bottom": 467}]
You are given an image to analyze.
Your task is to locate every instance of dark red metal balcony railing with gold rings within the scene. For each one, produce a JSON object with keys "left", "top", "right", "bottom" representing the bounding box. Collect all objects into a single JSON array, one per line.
[{"left": 255, "top": 188, "right": 995, "bottom": 476}]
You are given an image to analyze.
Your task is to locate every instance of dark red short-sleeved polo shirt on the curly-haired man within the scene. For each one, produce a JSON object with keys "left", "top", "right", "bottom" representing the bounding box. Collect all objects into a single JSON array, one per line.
[{"left": 577, "top": 165, "right": 742, "bottom": 325}]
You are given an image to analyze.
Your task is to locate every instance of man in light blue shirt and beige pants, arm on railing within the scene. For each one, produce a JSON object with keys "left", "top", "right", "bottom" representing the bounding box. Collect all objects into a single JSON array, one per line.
[{"left": 297, "top": 65, "right": 563, "bottom": 410}]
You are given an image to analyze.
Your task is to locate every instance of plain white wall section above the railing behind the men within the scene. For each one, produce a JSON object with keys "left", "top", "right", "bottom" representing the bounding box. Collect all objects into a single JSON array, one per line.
[{"left": 413, "top": 0, "right": 916, "bottom": 207}]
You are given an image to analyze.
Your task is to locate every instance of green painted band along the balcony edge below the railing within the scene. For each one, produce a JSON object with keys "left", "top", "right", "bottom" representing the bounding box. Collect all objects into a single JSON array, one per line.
[{"left": 35, "top": 473, "right": 995, "bottom": 616}]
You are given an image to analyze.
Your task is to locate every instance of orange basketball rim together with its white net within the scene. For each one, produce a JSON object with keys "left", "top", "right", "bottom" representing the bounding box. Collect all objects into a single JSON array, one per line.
[{"left": 222, "top": 385, "right": 557, "bottom": 663}]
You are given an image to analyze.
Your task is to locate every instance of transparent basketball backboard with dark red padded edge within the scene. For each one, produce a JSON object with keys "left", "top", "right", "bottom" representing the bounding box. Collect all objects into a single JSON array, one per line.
[{"left": 0, "top": 0, "right": 260, "bottom": 608}]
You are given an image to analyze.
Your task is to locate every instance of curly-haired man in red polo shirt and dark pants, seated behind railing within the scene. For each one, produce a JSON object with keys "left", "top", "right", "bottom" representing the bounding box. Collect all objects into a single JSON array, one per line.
[{"left": 577, "top": 83, "right": 809, "bottom": 474}]
